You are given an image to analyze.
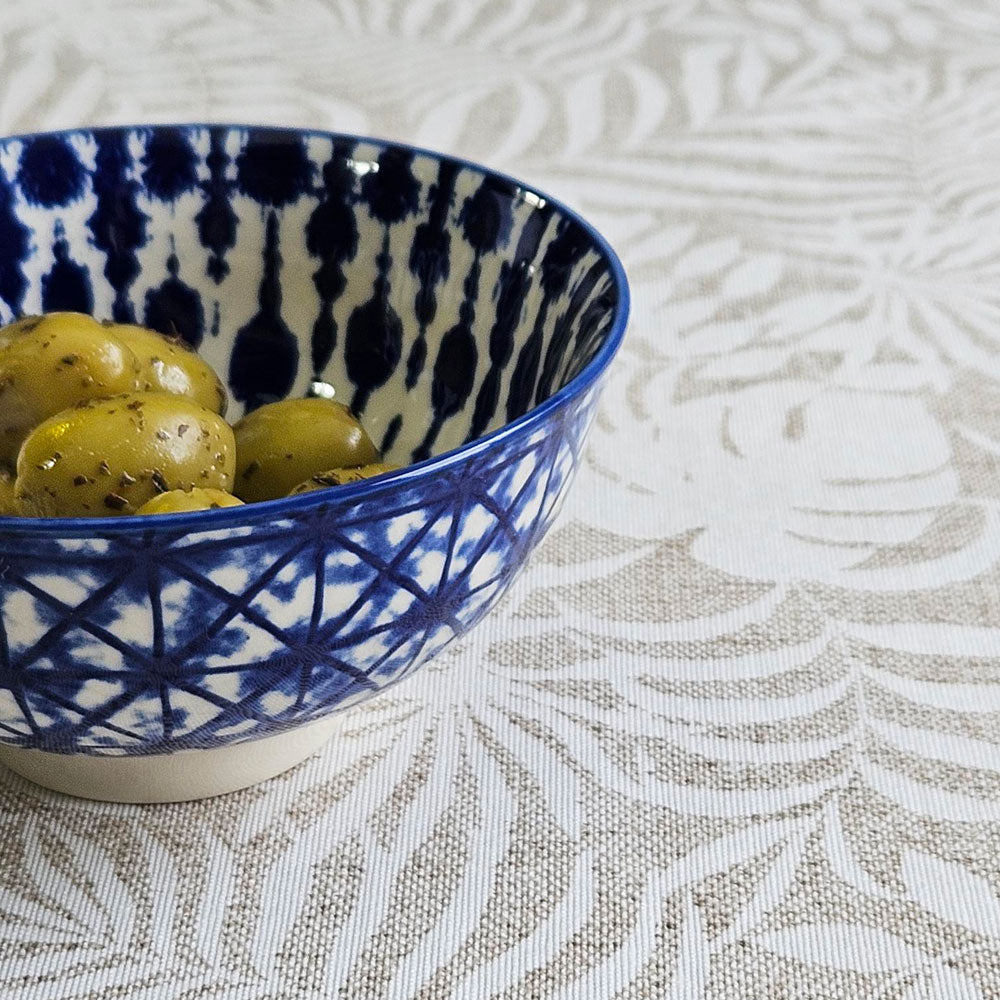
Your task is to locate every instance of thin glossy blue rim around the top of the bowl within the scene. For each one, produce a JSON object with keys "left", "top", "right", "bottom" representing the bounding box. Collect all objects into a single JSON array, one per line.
[{"left": 0, "top": 121, "right": 631, "bottom": 537}]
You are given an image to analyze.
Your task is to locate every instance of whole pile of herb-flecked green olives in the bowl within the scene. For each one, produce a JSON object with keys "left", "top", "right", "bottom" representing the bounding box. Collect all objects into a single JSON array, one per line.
[{"left": 0, "top": 312, "right": 394, "bottom": 517}]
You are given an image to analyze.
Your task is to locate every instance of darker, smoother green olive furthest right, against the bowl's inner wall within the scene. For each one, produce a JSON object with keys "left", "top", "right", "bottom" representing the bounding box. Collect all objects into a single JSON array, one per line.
[{"left": 233, "top": 398, "right": 379, "bottom": 503}]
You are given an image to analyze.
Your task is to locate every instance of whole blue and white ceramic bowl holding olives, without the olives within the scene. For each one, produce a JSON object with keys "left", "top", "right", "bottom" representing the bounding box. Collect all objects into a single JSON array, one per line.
[{"left": 0, "top": 125, "right": 628, "bottom": 801}]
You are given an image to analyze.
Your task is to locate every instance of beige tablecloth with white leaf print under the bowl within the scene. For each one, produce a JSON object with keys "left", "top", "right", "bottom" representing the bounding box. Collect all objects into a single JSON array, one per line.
[{"left": 0, "top": 0, "right": 1000, "bottom": 1000}]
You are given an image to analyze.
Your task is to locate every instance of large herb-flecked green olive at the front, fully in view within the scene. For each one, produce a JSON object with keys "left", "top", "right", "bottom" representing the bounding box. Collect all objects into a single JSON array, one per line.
[{"left": 15, "top": 392, "right": 236, "bottom": 517}]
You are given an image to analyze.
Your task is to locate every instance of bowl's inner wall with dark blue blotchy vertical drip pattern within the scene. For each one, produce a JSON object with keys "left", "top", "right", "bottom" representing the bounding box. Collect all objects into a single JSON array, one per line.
[{"left": 0, "top": 126, "right": 620, "bottom": 463}]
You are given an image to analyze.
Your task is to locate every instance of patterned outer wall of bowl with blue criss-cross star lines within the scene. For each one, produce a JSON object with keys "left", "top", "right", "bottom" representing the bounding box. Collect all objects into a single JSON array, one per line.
[{"left": 0, "top": 384, "right": 599, "bottom": 755}]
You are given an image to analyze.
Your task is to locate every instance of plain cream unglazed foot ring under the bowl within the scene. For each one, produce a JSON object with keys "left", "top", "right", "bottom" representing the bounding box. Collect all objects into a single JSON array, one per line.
[{"left": 0, "top": 715, "right": 337, "bottom": 802}]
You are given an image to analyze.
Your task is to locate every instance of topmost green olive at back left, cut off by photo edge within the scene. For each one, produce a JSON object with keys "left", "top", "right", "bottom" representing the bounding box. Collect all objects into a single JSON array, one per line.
[{"left": 0, "top": 313, "right": 139, "bottom": 462}]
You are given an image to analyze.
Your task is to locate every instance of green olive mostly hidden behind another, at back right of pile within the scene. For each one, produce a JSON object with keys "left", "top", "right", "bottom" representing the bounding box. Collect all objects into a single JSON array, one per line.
[{"left": 105, "top": 323, "right": 229, "bottom": 414}]
